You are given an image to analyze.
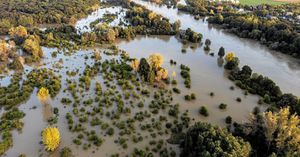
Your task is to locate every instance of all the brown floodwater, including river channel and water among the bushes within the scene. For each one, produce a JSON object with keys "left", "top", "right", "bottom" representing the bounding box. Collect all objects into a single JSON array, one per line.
[{"left": 0, "top": 0, "right": 300, "bottom": 157}]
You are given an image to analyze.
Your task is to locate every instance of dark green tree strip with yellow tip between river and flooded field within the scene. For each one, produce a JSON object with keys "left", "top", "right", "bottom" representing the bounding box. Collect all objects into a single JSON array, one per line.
[{"left": 224, "top": 53, "right": 300, "bottom": 115}]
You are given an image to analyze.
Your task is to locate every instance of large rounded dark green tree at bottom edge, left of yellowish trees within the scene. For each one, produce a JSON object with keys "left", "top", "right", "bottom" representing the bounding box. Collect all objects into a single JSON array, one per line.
[{"left": 180, "top": 122, "right": 251, "bottom": 157}]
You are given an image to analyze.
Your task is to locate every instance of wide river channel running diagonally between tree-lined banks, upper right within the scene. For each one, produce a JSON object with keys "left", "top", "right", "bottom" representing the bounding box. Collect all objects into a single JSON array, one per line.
[{"left": 132, "top": 0, "right": 300, "bottom": 96}]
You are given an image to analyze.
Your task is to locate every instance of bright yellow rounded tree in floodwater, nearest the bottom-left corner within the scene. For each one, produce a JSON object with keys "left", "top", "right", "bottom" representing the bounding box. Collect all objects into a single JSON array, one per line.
[{"left": 42, "top": 127, "right": 60, "bottom": 151}]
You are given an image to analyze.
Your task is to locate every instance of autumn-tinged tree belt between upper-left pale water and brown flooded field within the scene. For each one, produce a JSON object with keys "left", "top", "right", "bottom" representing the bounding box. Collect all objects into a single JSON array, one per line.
[{"left": 33, "top": 0, "right": 180, "bottom": 47}]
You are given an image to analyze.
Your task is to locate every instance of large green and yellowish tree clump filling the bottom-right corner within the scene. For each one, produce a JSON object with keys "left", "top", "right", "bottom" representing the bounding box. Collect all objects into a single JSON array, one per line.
[{"left": 177, "top": 104, "right": 300, "bottom": 157}]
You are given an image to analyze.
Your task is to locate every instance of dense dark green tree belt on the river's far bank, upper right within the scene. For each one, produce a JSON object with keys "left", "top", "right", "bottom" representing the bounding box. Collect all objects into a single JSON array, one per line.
[{"left": 208, "top": 14, "right": 300, "bottom": 57}]
